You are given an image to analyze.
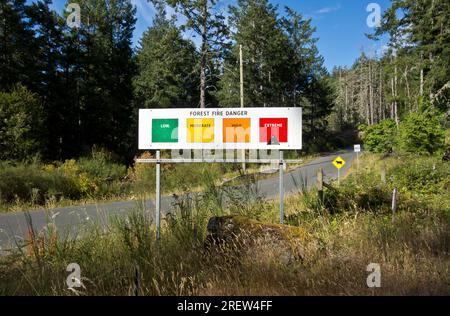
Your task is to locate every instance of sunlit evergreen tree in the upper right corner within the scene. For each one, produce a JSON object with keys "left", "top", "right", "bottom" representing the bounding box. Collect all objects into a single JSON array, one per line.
[{"left": 370, "top": 0, "right": 450, "bottom": 110}]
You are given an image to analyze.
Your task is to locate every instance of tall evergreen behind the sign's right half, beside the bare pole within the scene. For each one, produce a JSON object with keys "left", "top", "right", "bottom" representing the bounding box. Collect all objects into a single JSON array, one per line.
[{"left": 218, "top": 0, "right": 292, "bottom": 106}]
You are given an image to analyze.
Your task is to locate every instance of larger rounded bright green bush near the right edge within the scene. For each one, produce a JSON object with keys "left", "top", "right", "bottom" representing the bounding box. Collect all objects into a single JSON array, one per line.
[{"left": 398, "top": 113, "right": 444, "bottom": 154}]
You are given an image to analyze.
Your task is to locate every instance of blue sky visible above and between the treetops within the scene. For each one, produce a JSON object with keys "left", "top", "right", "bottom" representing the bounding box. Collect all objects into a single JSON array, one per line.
[{"left": 36, "top": 0, "right": 390, "bottom": 70}]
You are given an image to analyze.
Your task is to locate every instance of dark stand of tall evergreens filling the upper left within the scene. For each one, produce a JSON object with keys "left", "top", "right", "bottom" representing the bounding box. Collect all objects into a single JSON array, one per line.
[{"left": 0, "top": 0, "right": 136, "bottom": 159}]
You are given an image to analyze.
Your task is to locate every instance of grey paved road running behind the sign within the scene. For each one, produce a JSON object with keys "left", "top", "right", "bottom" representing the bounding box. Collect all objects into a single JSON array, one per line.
[{"left": 0, "top": 150, "right": 355, "bottom": 254}]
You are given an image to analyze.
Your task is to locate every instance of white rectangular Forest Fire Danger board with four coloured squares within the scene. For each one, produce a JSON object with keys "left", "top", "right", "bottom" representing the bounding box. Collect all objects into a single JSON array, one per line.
[{"left": 139, "top": 107, "right": 302, "bottom": 150}]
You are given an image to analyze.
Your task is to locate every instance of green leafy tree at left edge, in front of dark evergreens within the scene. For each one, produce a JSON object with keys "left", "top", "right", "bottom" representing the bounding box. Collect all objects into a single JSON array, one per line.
[{"left": 0, "top": 85, "right": 44, "bottom": 160}]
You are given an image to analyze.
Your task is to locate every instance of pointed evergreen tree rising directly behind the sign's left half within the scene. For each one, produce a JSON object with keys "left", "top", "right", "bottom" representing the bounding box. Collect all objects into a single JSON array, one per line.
[{"left": 134, "top": 6, "right": 199, "bottom": 108}]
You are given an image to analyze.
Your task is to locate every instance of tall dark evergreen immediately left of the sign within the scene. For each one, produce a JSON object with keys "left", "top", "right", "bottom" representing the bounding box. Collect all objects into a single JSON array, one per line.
[{"left": 64, "top": 0, "right": 136, "bottom": 155}]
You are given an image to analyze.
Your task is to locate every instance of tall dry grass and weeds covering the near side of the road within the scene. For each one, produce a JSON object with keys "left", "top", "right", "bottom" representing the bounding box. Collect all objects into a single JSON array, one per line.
[{"left": 0, "top": 156, "right": 450, "bottom": 295}]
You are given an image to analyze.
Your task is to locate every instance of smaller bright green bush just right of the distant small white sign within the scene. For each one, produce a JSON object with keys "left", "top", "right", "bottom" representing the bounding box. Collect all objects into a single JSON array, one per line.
[{"left": 359, "top": 119, "right": 397, "bottom": 153}]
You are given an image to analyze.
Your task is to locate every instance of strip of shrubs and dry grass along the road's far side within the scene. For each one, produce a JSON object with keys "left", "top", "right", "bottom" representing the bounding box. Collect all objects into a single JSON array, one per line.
[{"left": 0, "top": 147, "right": 320, "bottom": 212}]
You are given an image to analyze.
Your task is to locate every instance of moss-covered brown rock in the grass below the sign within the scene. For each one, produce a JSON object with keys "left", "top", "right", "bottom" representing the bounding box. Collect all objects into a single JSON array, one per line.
[{"left": 205, "top": 216, "right": 314, "bottom": 264}]
